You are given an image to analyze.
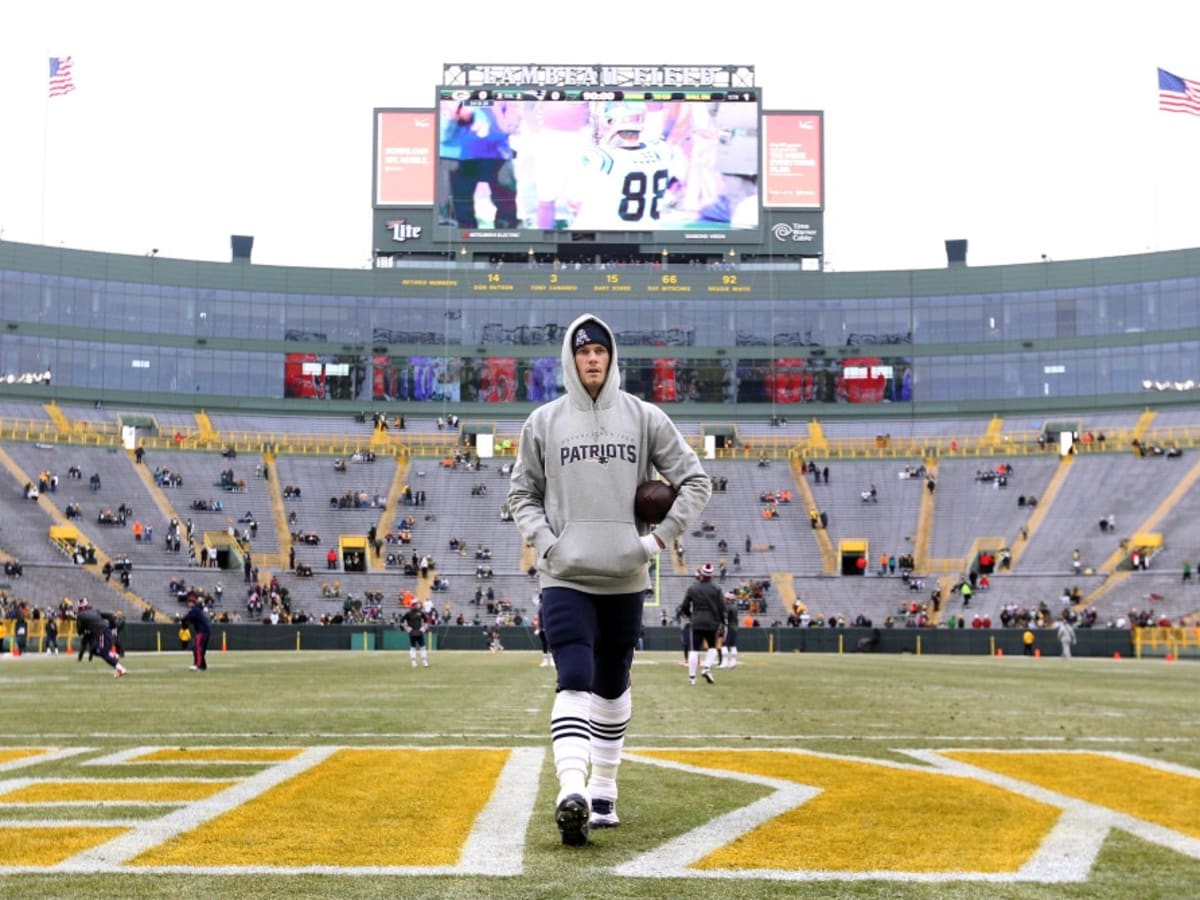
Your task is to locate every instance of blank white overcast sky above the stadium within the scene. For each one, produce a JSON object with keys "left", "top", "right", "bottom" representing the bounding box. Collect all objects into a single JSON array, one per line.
[{"left": 0, "top": 0, "right": 1200, "bottom": 271}]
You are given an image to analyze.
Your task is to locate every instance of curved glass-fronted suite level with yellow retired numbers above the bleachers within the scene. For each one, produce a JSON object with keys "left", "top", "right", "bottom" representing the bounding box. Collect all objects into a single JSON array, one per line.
[{"left": 0, "top": 242, "right": 1200, "bottom": 418}]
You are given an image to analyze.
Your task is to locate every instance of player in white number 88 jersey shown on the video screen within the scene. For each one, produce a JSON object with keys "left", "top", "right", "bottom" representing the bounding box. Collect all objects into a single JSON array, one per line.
[{"left": 569, "top": 102, "right": 679, "bottom": 232}]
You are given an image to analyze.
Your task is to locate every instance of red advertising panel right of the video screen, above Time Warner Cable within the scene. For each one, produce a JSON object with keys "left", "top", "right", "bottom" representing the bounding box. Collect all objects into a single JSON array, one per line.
[{"left": 762, "top": 112, "right": 824, "bottom": 210}]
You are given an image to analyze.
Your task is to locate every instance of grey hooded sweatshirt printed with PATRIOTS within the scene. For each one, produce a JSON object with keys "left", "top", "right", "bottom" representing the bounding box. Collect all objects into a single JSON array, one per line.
[{"left": 509, "top": 314, "right": 712, "bottom": 594}]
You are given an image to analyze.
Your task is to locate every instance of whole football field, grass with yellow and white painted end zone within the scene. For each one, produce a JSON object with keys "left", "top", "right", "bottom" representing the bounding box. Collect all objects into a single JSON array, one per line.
[{"left": 0, "top": 650, "right": 1200, "bottom": 900}]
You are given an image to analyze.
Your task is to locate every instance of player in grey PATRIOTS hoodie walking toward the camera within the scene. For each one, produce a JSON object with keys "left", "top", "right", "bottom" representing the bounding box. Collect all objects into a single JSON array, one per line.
[{"left": 509, "top": 316, "right": 712, "bottom": 846}]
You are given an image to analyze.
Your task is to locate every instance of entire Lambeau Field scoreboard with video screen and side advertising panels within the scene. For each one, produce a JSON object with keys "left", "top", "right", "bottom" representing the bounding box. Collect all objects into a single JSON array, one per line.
[{"left": 372, "top": 64, "right": 824, "bottom": 260}]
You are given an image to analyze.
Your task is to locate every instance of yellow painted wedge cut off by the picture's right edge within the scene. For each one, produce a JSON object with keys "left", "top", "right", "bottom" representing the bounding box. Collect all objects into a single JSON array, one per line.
[{"left": 943, "top": 751, "right": 1200, "bottom": 838}]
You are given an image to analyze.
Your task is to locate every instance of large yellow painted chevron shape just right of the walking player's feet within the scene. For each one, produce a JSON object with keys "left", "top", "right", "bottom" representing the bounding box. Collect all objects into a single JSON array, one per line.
[{"left": 638, "top": 750, "right": 1061, "bottom": 872}]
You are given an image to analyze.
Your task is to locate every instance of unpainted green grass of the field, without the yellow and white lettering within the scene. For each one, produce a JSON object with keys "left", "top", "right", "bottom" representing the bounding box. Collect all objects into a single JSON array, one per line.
[{"left": 0, "top": 652, "right": 1200, "bottom": 900}]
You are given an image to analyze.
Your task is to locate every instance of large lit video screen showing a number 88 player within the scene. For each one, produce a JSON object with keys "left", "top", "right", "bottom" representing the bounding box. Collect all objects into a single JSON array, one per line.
[{"left": 436, "top": 88, "right": 762, "bottom": 238}]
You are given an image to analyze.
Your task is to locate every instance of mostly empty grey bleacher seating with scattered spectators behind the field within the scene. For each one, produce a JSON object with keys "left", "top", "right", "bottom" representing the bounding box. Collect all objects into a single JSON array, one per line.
[{"left": 0, "top": 403, "right": 1200, "bottom": 626}]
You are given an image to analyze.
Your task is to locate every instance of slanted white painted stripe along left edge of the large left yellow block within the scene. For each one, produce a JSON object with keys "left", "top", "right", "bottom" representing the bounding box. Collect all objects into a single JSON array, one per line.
[{"left": 51, "top": 746, "right": 340, "bottom": 872}]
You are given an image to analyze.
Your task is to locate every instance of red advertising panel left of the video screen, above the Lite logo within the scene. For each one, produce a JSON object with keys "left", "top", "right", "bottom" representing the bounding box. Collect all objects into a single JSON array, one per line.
[{"left": 374, "top": 109, "right": 437, "bottom": 206}]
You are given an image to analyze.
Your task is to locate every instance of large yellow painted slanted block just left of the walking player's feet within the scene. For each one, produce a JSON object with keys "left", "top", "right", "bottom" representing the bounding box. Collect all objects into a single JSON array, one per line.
[{"left": 130, "top": 749, "right": 510, "bottom": 866}]
